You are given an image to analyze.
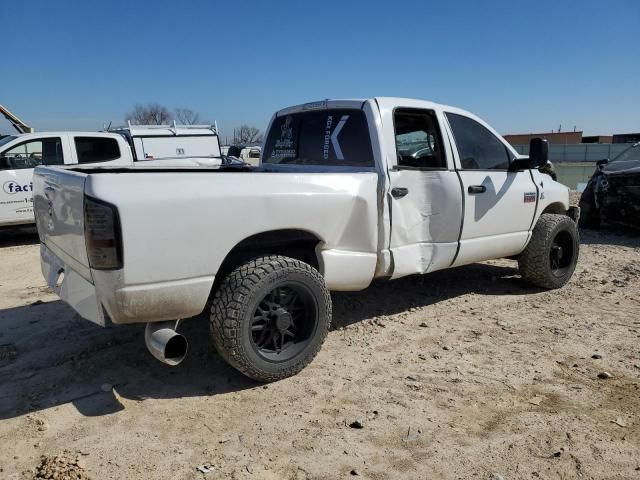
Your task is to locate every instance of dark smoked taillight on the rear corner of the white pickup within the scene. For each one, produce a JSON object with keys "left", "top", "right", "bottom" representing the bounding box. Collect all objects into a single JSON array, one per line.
[{"left": 84, "top": 196, "right": 122, "bottom": 270}]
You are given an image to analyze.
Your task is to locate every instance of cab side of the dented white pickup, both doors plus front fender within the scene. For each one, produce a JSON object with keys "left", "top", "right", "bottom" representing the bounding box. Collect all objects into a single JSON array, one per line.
[{"left": 377, "top": 98, "right": 569, "bottom": 278}]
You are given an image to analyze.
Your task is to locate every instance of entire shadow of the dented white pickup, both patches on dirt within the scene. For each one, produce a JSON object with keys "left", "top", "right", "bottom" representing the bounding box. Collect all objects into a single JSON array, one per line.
[{"left": 0, "top": 258, "right": 537, "bottom": 419}]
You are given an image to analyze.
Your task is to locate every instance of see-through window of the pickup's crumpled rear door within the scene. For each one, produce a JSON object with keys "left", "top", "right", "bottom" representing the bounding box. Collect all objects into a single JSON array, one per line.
[{"left": 393, "top": 108, "right": 447, "bottom": 169}]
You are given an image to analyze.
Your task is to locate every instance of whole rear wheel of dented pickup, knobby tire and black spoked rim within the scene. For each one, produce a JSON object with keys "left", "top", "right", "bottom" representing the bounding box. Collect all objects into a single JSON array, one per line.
[{"left": 210, "top": 255, "right": 331, "bottom": 382}]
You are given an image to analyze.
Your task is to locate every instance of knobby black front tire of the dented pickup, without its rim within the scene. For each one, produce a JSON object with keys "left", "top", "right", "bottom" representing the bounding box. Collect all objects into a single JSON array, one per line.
[{"left": 518, "top": 213, "right": 580, "bottom": 289}]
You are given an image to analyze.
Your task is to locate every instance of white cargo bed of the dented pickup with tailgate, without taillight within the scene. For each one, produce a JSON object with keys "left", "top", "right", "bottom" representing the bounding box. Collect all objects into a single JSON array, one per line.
[{"left": 34, "top": 167, "right": 379, "bottom": 323}]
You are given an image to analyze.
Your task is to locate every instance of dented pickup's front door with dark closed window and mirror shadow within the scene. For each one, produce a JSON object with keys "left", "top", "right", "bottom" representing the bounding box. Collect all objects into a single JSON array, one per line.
[{"left": 445, "top": 112, "right": 538, "bottom": 265}]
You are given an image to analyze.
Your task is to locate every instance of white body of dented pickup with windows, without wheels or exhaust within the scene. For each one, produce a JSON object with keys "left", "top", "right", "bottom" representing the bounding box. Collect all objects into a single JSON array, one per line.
[{"left": 34, "top": 98, "right": 569, "bottom": 324}]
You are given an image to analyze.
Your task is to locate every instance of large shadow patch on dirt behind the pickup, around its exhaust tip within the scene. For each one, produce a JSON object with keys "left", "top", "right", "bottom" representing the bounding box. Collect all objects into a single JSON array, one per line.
[{"left": 0, "top": 301, "right": 257, "bottom": 419}]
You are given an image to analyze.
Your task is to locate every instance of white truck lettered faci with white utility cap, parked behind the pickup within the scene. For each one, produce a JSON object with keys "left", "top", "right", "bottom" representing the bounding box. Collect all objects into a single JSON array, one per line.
[{"left": 0, "top": 125, "right": 221, "bottom": 226}]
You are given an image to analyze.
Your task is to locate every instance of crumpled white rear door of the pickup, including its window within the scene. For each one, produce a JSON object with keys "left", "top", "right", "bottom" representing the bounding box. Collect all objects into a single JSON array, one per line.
[{"left": 377, "top": 98, "right": 462, "bottom": 278}]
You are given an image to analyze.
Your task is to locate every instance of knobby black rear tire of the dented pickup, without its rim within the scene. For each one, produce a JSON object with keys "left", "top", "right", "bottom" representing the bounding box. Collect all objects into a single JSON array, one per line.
[{"left": 209, "top": 255, "right": 332, "bottom": 382}]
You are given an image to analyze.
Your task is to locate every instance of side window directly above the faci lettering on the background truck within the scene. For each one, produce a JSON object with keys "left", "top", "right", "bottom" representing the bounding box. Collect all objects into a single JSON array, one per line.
[{"left": 0, "top": 137, "right": 64, "bottom": 170}]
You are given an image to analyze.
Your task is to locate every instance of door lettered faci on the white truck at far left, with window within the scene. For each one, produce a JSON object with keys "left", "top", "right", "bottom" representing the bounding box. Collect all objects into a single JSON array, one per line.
[{"left": 0, "top": 136, "right": 64, "bottom": 225}]
